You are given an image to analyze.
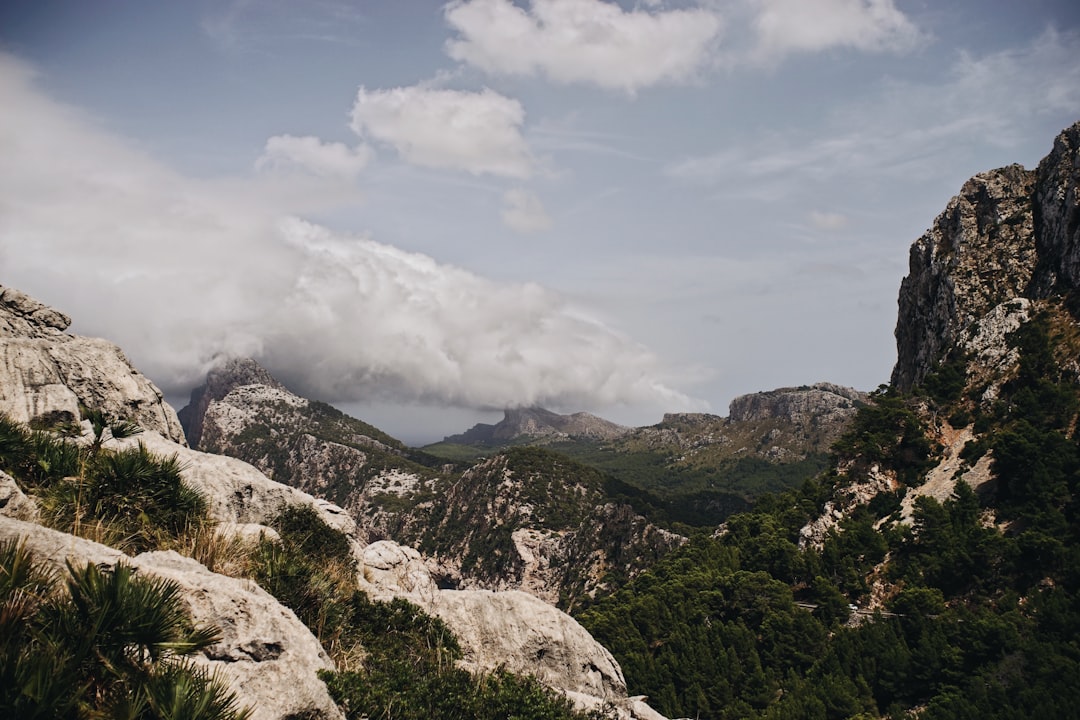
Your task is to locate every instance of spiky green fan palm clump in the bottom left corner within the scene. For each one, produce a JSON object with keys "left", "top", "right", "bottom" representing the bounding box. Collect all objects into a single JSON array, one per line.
[{"left": 0, "top": 540, "right": 249, "bottom": 720}]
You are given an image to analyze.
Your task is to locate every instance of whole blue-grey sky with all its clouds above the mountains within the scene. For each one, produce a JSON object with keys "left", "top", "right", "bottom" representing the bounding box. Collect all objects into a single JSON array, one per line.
[{"left": 0, "top": 0, "right": 1080, "bottom": 444}]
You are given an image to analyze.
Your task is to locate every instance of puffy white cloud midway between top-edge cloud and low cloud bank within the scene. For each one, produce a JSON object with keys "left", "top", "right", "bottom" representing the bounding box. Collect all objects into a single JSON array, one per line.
[{"left": 352, "top": 85, "right": 536, "bottom": 178}]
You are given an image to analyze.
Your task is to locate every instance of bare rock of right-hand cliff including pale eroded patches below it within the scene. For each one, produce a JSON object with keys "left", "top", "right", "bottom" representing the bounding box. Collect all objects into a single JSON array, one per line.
[{"left": 800, "top": 122, "right": 1080, "bottom": 561}]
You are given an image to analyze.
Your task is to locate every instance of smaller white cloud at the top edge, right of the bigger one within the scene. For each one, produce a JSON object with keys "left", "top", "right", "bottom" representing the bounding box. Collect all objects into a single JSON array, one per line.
[{"left": 753, "top": 0, "right": 922, "bottom": 60}]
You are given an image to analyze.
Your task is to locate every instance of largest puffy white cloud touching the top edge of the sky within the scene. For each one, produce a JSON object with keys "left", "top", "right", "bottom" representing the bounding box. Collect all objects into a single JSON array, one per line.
[{"left": 445, "top": 0, "right": 724, "bottom": 93}]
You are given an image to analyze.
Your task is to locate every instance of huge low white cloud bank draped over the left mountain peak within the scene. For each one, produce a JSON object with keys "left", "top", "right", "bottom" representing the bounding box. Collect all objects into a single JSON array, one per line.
[{"left": 0, "top": 55, "right": 698, "bottom": 409}]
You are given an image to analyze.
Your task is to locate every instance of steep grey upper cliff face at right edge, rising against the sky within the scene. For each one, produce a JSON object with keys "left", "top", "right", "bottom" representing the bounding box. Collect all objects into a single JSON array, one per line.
[{"left": 892, "top": 123, "right": 1080, "bottom": 391}]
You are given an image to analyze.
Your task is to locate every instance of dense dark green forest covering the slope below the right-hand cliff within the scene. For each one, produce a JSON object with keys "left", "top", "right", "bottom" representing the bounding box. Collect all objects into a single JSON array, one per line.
[{"left": 578, "top": 305, "right": 1080, "bottom": 719}]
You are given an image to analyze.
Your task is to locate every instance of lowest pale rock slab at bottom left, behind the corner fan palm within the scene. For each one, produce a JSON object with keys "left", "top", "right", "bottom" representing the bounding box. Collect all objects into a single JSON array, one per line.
[{"left": 0, "top": 516, "right": 343, "bottom": 720}]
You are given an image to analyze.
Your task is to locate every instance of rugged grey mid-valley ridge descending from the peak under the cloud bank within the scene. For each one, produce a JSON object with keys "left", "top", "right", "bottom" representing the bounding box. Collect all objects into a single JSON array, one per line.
[{"left": 181, "top": 359, "right": 685, "bottom": 604}]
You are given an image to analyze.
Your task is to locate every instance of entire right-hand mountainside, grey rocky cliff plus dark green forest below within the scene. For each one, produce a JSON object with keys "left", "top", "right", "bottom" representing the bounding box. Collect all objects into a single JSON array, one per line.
[{"left": 579, "top": 123, "right": 1080, "bottom": 720}]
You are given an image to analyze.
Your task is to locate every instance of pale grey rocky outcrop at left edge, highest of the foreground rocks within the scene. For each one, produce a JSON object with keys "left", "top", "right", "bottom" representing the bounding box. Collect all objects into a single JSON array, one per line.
[{"left": 0, "top": 286, "right": 185, "bottom": 444}]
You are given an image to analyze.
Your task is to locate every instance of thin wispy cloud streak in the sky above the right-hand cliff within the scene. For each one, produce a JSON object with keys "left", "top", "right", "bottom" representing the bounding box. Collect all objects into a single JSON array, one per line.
[{"left": 666, "top": 30, "right": 1080, "bottom": 186}]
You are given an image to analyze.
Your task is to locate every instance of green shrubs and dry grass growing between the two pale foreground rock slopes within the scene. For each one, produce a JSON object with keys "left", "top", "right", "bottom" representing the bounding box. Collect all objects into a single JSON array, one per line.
[{"left": 243, "top": 508, "right": 600, "bottom": 720}]
